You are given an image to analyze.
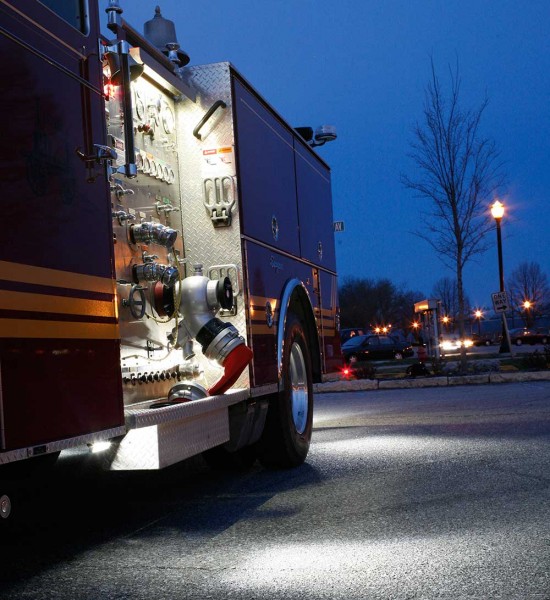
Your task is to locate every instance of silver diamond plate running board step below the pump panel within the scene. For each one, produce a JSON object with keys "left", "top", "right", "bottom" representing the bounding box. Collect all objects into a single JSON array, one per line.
[{"left": 109, "top": 389, "right": 250, "bottom": 471}]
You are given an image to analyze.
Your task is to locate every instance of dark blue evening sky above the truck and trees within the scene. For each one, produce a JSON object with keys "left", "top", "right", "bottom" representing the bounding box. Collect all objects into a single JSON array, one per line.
[{"left": 101, "top": 0, "right": 550, "bottom": 306}]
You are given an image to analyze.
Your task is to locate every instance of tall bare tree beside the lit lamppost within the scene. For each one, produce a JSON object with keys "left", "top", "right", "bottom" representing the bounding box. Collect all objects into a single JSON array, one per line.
[{"left": 402, "top": 60, "right": 503, "bottom": 360}]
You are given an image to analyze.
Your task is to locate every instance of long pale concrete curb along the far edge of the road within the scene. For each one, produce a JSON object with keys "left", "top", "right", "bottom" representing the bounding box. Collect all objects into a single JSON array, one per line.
[{"left": 313, "top": 371, "right": 550, "bottom": 394}]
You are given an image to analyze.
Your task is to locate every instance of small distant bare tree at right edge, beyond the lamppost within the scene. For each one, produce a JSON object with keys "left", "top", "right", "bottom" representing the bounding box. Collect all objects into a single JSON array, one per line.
[{"left": 508, "top": 262, "right": 550, "bottom": 327}]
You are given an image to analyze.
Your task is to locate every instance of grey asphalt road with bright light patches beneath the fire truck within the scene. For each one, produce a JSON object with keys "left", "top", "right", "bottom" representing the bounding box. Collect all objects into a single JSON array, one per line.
[{"left": 0, "top": 382, "right": 550, "bottom": 600}]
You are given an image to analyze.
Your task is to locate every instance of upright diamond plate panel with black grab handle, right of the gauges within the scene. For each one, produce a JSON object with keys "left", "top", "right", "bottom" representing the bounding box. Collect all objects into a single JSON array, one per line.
[{"left": 176, "top": 63, "right": 250, "bottom": 387}]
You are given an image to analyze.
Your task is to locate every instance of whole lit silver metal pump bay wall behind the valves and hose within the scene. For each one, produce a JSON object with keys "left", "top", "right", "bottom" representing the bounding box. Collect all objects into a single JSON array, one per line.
[{"left": 107, "top": 63, "right": 249, "bottom": 407}]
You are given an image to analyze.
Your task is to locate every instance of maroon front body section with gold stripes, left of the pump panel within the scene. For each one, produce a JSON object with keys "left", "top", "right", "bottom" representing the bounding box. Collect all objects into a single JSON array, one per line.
[{"left": 0, "top": 0, "right": 123, "bottom": 450}]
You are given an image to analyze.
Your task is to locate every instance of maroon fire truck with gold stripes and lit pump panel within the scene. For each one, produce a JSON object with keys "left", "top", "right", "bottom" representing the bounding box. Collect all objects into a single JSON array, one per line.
[{"left": 0, "top": 0, "right": 341, "bottom": 521}]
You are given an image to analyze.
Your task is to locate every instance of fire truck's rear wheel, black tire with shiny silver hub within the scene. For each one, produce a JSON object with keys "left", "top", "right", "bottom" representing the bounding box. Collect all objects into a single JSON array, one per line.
[{"left": 257, "top": 313, "right": 313, "bottom": 468}]
